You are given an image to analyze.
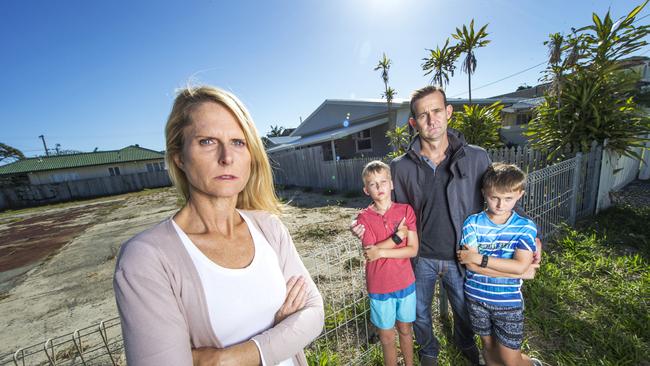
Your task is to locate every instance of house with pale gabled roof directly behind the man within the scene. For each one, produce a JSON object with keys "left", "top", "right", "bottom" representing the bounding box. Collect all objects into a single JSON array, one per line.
[{"left": 267, "top": 98, "right": 521, "bottom": 161}]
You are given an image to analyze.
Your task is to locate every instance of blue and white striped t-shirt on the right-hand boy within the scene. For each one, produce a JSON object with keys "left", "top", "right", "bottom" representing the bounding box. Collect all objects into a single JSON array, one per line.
[{"left": 460, "top": 211, "right": 537, "bottom": 307}]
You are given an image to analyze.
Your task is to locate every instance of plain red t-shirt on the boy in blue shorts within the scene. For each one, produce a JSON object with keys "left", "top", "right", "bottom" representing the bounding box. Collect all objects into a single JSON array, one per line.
[{"left": 357, "top": 202, "right": 417, "bottom": 294}]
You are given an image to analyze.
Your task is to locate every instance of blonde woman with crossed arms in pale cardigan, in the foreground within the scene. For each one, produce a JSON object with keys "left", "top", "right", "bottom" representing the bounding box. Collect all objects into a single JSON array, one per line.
[{"left": 114, "top": 87, "right": 324, "bottom": 366}]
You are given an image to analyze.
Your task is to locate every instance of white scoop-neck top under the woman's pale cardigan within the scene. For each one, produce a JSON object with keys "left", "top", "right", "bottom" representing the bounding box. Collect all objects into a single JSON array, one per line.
[{"left": 172, "top": 210, "right": 294, "bottom": 366}]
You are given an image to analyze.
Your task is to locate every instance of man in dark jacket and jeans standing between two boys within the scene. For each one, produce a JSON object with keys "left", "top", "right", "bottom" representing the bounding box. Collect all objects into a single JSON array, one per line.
[{"left": 352, "top": 86, "right": 539, "bottom": 366}]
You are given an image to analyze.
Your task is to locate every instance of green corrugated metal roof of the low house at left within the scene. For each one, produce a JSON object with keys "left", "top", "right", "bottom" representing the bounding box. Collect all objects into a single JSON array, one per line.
[{"left": 0, "top": 146, "right": 165, "bottom": 175}]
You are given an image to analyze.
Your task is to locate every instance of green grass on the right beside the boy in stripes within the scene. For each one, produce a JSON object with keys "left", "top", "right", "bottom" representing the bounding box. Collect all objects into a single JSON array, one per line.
[{"left": 524, "top": 206, "right": 650, "bottom": 365}]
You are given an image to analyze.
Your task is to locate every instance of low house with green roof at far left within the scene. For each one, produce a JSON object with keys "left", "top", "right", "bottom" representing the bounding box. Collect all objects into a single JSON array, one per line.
[{"left": 0, "top": 145, "right": 165, "bottom": 186}]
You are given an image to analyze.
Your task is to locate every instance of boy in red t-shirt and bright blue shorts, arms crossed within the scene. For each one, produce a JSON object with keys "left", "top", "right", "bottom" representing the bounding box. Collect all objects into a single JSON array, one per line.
[{"left": 357, "top": 160, "right": 418, "bottom": 366}]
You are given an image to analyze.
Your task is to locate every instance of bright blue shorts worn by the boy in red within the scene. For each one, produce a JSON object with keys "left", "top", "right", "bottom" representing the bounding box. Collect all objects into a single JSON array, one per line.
[{"left": 368, "top": 282, "right": 415, "bottom": 329}]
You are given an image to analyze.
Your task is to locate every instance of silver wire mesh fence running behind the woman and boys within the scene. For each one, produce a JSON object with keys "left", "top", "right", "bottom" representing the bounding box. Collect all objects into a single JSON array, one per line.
[{"left": 0, "top": 144, "right": 632, "bottom": 366}]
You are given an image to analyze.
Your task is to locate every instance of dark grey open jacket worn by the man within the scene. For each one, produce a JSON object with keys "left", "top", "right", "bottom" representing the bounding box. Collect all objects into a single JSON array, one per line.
[{"left": 390, "top": 129, "right": 491, "bottom": 264}]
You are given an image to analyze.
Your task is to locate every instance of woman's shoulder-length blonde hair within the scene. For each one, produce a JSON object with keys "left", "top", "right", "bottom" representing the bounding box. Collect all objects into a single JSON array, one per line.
[{"left": 165, "top": 86, "right": 282, "bottom": 213}]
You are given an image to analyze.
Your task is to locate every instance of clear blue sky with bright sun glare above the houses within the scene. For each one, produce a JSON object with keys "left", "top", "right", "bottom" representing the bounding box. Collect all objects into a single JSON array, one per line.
[{"left": 0, "top": 0, "right": 650, "bottom": 156}]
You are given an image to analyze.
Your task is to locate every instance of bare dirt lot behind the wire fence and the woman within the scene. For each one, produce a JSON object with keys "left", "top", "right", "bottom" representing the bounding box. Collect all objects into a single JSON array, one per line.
[{"left": 0, "top": 188, "right": 369, "bottom": 355}]
